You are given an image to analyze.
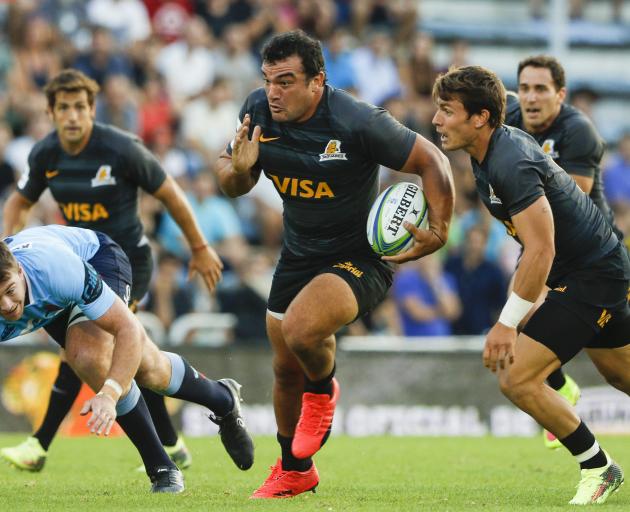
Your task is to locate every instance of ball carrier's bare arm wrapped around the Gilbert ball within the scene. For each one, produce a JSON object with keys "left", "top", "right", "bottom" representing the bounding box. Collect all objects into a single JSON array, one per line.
[{"left": 383, "top": 135, "right": 455, "bottom": 263}]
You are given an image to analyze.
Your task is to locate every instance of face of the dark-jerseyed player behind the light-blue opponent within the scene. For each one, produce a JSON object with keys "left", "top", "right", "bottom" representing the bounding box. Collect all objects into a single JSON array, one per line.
[{"left": 50, "top": 90, "right": 95, "bottom": 152}]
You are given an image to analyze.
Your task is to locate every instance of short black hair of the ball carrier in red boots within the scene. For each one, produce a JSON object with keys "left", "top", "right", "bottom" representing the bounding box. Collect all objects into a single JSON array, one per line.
[{"left": 261, "top": 29, "right": 326, "bottom": 79}]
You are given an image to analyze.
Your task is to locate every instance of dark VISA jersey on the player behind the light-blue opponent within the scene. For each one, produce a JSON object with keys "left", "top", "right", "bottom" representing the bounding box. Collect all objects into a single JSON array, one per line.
[{"left": 18, "top": 123, "right": 166, "bottom": 248}]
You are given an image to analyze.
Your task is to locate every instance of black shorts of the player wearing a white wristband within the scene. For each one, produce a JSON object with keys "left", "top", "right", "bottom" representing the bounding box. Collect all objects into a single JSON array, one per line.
[{"left": 523, "top": 277, "right": 630, "bottom": 364}]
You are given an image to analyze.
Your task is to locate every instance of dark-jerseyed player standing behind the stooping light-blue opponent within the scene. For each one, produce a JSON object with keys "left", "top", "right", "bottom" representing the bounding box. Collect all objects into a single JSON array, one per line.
[{"left": 0, "top": 69, "right": 222, "bottom": 471}]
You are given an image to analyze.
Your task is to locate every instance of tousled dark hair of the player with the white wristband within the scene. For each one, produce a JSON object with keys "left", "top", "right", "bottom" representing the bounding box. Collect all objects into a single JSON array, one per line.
[{"left": 433, "top": 66, "right": 505, "bottom": 128}]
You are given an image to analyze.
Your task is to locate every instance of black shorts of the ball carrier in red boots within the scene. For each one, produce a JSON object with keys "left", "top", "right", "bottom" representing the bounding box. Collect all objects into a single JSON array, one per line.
[{"left": 267, "top": 252, "right": 394, "bottom": 318}]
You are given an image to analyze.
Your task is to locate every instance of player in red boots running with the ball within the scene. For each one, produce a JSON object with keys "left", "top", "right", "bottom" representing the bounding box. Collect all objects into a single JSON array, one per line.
[{"left": 217, "top": 30, "right": 454, "bottom": 498}]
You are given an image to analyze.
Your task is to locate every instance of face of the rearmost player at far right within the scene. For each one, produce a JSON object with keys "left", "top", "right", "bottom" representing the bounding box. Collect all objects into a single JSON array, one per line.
[{"left": 518, "top": 66, "right": 566, "bottom": 133}]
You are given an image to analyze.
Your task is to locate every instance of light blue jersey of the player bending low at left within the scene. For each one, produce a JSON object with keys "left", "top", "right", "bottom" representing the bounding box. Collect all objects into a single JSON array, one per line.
[{"left": 0, "top": 226, "right": 116, "bottom": 341}]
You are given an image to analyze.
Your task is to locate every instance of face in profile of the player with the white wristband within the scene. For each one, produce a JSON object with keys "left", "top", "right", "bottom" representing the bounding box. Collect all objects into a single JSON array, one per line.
[{"left": 431, "top": 99, "right": 477, "bottom": 151}]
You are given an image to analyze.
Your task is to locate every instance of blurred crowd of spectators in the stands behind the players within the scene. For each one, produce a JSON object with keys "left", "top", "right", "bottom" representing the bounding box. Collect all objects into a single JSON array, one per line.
[{"left": 0, "top": 0, "right": 630, "bottom": 343}]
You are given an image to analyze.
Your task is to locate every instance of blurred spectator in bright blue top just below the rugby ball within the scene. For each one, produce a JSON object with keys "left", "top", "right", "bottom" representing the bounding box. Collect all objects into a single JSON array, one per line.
[{"left": 392, "top": 254, "right": 461, "bottom": 336}]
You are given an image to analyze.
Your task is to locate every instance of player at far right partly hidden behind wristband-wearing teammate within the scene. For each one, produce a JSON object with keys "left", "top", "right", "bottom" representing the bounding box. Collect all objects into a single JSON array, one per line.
[{"left": 505, "top": 55, "right": 623, "bottom": 449}]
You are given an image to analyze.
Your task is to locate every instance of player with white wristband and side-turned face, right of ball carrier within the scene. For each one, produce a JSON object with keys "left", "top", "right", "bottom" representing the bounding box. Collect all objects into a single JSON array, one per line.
[{"left": 433, "top": 66, "right": 630, "bottom": 505}]
